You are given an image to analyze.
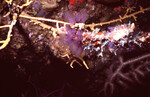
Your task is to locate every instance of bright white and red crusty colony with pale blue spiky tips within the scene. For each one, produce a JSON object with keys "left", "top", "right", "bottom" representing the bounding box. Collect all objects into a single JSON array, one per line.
[{"left": 83, "top": 23, "right": 137, "bottom": 56}]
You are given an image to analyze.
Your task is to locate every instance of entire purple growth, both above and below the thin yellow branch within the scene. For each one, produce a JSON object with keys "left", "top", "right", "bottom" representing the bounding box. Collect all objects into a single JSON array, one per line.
[{"left": 60, "top": 9, "right": 89, "bottom": 57}]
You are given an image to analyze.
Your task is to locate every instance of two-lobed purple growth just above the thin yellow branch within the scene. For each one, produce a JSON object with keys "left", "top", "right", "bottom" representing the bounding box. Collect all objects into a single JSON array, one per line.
[{"left": 62, "top": 9, "right": 89, "bottom": 25}]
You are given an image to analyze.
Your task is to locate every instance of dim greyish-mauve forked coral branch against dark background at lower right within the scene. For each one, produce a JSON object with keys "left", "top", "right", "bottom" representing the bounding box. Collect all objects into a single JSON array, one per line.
[{"left": 104, "top": 54, "right": 150, "bottom": 93}]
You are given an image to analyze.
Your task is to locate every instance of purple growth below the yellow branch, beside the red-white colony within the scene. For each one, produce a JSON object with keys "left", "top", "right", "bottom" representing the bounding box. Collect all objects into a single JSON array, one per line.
[{"left": 60, "top": 26, "right": 83, "bottom": 57}]
